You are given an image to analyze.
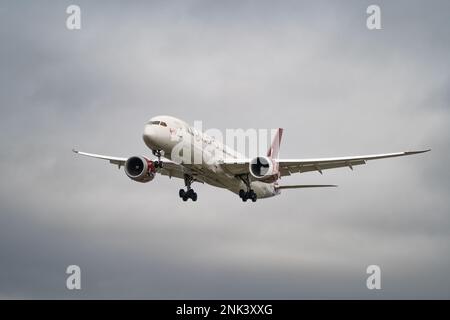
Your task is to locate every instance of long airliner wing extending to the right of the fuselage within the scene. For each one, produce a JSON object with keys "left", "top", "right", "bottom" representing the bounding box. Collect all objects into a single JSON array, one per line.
[{"left": 222, "top": 149, "right": 430, "bottom": 176}]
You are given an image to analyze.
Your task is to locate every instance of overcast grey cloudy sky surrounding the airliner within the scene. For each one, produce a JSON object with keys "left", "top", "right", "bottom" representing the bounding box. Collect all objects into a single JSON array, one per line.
[{"left": 0, "top": 0, "right": 450, "bottom": 299}]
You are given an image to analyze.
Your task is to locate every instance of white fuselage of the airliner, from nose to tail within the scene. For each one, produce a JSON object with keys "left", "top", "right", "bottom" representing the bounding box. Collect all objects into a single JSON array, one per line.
[{"left": 143, "top": 116, "right": 279, "bottom": 198}]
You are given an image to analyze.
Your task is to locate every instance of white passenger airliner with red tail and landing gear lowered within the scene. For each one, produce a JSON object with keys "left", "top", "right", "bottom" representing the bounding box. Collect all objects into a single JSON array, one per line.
[{"left": 73, "top": 115, "right": 431, "bottom": 202}]
